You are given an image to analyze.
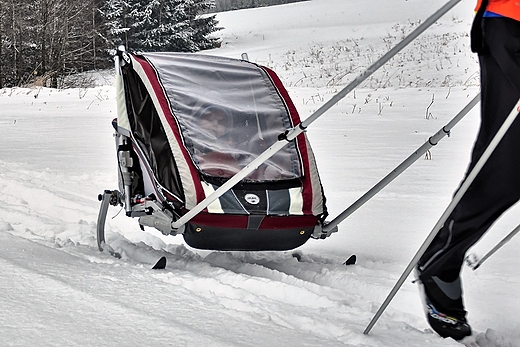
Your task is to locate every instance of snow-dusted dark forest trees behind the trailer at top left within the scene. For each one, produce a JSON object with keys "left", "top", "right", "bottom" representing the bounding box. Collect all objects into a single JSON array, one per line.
[{"left": 0, "top": 0, "right": 301, "bottom": 88}]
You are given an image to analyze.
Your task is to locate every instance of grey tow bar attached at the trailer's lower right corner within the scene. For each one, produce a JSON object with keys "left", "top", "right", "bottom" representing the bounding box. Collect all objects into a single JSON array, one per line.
[{"left": 323, "top": 94, "right": 480, "bottom": 232}]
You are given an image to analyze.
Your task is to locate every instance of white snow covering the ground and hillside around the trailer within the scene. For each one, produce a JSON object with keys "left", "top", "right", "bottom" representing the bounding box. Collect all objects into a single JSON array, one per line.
[{"left": 0, "top": 0, "right": 520, "bottom": 347}]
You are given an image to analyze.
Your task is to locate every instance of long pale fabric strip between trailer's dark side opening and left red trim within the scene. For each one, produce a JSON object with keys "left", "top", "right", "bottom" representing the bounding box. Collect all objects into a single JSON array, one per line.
[{"left": 130, "top": 56, "right": 197, "bottom": 210}]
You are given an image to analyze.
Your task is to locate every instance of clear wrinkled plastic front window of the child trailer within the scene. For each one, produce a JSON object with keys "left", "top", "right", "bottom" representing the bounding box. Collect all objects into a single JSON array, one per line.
[{"left": 146, "top": 53, "right": 301, "bottom": 181}]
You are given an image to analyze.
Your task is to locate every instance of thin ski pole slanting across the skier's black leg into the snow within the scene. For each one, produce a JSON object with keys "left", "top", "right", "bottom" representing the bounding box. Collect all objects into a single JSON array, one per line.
[{"left": 363, "top": 96, "right": 520, "bottom": 335}]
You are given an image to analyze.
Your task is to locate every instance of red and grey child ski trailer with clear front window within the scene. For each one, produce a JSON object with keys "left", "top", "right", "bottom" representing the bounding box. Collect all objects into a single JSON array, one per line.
[{"left": 98, "top": 50, "right": 327, "bottom": 251}]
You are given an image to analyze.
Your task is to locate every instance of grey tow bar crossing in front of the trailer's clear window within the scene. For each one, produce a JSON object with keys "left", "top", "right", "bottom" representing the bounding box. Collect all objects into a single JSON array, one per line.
[{"left": 172, "top": 0, "right": 461, "bottom": 234}]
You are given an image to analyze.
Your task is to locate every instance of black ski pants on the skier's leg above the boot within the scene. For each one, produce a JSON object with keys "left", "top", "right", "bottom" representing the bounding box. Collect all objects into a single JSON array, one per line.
[{"left": 419, "top": 18, "right": 520, "bottom": 282}]
